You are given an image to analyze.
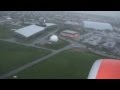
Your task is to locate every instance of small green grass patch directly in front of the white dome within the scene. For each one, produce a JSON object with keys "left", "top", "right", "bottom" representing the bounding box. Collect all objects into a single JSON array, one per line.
[{"left": 36, "top": 39, "right": 69, "bottom": 50}]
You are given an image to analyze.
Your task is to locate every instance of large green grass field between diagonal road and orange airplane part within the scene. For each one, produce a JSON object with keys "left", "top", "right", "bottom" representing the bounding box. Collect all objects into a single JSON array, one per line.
[{"left": 9, "top": 47, "right": 105, "bottom": 79}]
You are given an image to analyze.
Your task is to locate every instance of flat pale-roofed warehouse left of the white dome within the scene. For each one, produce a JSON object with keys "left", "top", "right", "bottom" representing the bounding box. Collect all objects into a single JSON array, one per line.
[{"left": 14, "top": 25, "right": 45, "bottom": 38}]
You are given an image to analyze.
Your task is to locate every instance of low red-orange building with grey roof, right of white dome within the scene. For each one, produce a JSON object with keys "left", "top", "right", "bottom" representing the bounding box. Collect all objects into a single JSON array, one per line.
[{"left": 60, "top": 30, "right": 80, "bottom": 39}]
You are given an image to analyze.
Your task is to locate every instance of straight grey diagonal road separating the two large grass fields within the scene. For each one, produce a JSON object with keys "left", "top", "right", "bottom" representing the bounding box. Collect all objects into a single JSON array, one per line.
[{"left": 0, "top": 45, "right": 72, "bottom": 79}]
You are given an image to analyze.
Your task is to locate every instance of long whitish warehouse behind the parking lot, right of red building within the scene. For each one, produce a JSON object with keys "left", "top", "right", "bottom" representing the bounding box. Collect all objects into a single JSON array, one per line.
[{"left": 83, "top": 21, "right": 113, "bottom": 31}]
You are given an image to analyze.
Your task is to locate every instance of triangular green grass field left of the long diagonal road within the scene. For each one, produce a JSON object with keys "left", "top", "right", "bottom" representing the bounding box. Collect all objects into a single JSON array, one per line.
[{"left": 0, "top": 41, "right": 50, "bottom": 75}]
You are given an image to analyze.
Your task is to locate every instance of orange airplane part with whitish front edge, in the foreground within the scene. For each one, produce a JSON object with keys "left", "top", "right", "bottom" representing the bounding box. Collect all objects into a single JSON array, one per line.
[{"left": 88, "top": 59, "right": 120, "bottom": 79}]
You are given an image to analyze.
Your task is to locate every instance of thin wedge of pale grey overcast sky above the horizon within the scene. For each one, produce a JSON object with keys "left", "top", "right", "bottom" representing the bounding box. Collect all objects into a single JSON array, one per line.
[{"left": 72, "top": 11, "right": 120, "bottom": 18}]
